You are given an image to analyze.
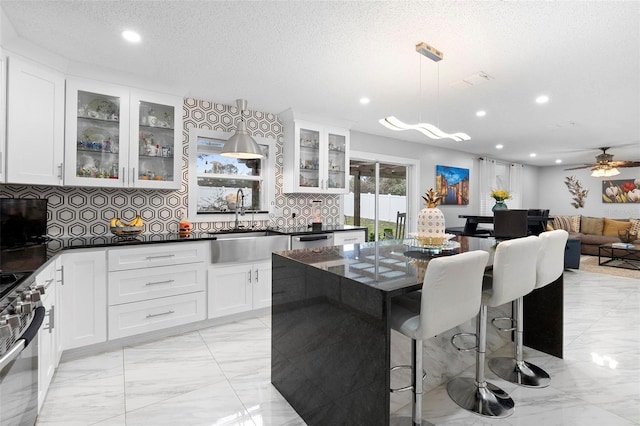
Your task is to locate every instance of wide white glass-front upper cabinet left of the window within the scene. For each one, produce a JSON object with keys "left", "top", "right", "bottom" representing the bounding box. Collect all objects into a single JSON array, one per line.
[{"left": 65, "top": 81, "right": 182, "bottom": 189}]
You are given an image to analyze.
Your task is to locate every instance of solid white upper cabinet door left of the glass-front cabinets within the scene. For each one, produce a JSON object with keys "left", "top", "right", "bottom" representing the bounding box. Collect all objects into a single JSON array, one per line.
[{"left": 2, "top": 56, "right": 65, "bottom": 185}]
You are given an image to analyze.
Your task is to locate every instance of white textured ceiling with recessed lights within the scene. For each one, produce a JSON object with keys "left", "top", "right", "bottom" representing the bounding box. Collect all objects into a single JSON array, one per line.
[{"left": 0, "top": 0, "right": 640, "bottom": 165}]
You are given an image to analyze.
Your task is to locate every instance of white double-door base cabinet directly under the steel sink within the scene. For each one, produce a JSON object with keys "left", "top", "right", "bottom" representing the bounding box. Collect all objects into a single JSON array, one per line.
[{"left": 208, "top": 260, "right": 271, "bottom": 318}]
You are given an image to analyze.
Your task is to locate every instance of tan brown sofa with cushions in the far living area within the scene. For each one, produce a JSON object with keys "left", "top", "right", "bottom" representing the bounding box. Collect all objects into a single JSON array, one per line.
[{"left": 547, "top": 215, "right": 640, "bottom": 256}]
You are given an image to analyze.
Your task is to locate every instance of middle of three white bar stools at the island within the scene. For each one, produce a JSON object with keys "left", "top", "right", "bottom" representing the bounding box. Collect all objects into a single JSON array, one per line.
[{"left": 447, "top": 236, "right": 540, "bottom": 418}]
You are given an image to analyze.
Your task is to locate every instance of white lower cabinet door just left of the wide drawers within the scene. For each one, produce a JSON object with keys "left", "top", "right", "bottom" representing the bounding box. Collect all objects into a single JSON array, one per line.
[{"left": 60, "top": 250, "right": 107, "bottom": 350}]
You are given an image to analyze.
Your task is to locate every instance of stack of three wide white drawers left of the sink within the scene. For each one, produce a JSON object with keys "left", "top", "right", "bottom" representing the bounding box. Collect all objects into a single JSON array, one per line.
[{"left": 108, "top": 243, "right": 207, "bottom": 340}]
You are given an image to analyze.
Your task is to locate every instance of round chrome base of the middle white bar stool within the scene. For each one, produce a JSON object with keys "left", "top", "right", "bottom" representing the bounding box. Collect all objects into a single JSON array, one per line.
[{"left": 447, "top": 377, "right": 515, "bottom": 418}]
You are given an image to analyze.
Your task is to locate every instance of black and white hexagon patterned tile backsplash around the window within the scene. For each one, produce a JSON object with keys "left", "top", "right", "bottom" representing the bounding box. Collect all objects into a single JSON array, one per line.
[{"left": 0, "top": 98, "right": 340, "bottom": 237}]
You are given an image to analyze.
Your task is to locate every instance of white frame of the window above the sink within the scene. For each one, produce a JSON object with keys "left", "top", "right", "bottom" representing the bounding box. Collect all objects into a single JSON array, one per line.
[{"left": 187, "top": 127, "right": 276, "bottom": 222}]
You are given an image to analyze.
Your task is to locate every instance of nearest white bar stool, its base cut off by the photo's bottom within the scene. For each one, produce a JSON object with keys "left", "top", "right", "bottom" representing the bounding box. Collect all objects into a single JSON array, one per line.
[{"left": 390, "top": 251, "right": 489, "bottom": 426}]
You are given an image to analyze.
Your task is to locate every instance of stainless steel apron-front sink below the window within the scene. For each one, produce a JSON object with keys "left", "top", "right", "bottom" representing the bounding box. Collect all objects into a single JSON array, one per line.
[{"left": 211, "top": 230, "right": 290, "bottom": 263}]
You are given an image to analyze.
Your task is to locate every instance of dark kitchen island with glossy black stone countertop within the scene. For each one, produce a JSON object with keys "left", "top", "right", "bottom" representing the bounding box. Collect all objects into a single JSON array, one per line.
[{"left": 271, "top": 237, "right": 562, "bottom": 426}]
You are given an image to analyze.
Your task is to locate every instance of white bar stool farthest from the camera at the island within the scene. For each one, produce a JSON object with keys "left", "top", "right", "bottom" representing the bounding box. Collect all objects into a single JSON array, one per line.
[{"left": 489, "top": 229, "right": 569, "bottom": 388}]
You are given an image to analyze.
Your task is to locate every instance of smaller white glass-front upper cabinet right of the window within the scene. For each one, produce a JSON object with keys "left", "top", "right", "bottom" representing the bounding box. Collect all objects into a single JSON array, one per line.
[{"left": 283, "top": 113, "right": 349, "bottom": 194}]
